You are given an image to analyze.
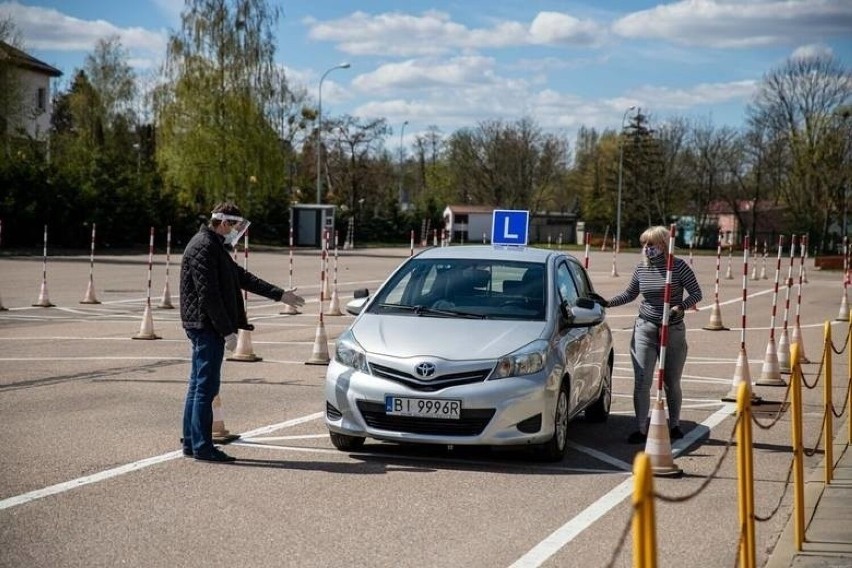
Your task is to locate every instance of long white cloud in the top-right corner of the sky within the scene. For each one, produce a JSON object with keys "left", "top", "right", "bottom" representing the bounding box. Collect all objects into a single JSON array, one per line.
[{"left": 612, "top": 0, "right": 852, "bottom": 48}]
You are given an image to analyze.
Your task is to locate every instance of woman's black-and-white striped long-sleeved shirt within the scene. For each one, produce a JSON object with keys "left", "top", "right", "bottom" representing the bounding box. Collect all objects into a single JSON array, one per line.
[{"left": 608, "top": 253, "right": 702, "bottom": 325}]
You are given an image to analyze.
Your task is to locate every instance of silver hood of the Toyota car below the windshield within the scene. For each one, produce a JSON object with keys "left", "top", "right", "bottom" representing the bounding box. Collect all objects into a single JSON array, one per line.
[{"left": 352, "top": 313, "right": 547, "bottom": 361}]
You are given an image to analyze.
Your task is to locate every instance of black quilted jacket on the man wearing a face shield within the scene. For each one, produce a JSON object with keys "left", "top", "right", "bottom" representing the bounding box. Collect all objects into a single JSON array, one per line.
[{"left": 180, "top": 227, "right": 284, "bottom": 337}]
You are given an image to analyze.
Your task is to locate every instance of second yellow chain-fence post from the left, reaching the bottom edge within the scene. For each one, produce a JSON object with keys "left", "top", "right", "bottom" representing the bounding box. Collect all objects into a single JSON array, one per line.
[{"left": 737, "top": 383, "right": 757, "bottom": 568}]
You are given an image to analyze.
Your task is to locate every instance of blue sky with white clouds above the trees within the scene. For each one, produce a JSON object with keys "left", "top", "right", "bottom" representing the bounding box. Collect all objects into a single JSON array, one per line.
[{"left": 0, "top": 0, "right": 852, "bottom": 147}]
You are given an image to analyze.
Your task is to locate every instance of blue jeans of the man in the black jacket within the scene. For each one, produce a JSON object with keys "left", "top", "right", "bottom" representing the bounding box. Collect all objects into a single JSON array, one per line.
[{"left": 183, "top": 329, "right": 225, "bottom": 456}]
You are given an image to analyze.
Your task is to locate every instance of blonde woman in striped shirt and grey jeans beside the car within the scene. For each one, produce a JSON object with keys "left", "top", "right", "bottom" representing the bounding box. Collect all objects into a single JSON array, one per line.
[{"left": 607, "top": 226, "right": 701, "bottom": 444}]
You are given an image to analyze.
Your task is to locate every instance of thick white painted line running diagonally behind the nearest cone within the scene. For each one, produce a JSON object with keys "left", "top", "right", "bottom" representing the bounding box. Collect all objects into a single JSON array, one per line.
[{"left": 510, "top": 403, "right": 736, "bottom": 568}]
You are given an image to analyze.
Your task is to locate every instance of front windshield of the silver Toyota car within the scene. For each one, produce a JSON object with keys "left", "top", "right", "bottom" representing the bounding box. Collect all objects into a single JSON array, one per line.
[{"left": 369, "top": 258, "right": 546, "bottom": 320}]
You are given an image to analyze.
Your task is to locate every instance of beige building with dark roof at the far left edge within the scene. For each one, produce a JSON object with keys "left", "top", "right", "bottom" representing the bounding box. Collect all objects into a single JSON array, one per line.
[{"left": 0, "top": 41, "right": 62, "bottom": 140}]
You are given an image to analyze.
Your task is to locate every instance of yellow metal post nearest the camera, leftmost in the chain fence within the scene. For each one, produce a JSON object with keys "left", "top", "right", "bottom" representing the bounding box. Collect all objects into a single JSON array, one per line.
[{"left": 633, "top": 452, "right": 657, "bottom": 568}]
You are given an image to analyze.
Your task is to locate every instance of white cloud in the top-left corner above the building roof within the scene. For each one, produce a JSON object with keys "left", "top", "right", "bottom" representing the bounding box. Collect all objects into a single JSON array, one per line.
[{"left": 0, "top": 2, "right": 167, "bottom": 54}]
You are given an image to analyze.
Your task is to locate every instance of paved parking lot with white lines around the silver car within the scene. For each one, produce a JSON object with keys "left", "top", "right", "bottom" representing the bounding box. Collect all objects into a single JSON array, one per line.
[{"left": 0, "top": 245, "right": 849, "bottom": 567}]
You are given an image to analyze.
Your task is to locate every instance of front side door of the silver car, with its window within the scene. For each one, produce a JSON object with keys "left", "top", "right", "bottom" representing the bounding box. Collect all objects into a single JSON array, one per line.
[{"left": 555, "top": 259, "right": 592, "bottom": 415}]
